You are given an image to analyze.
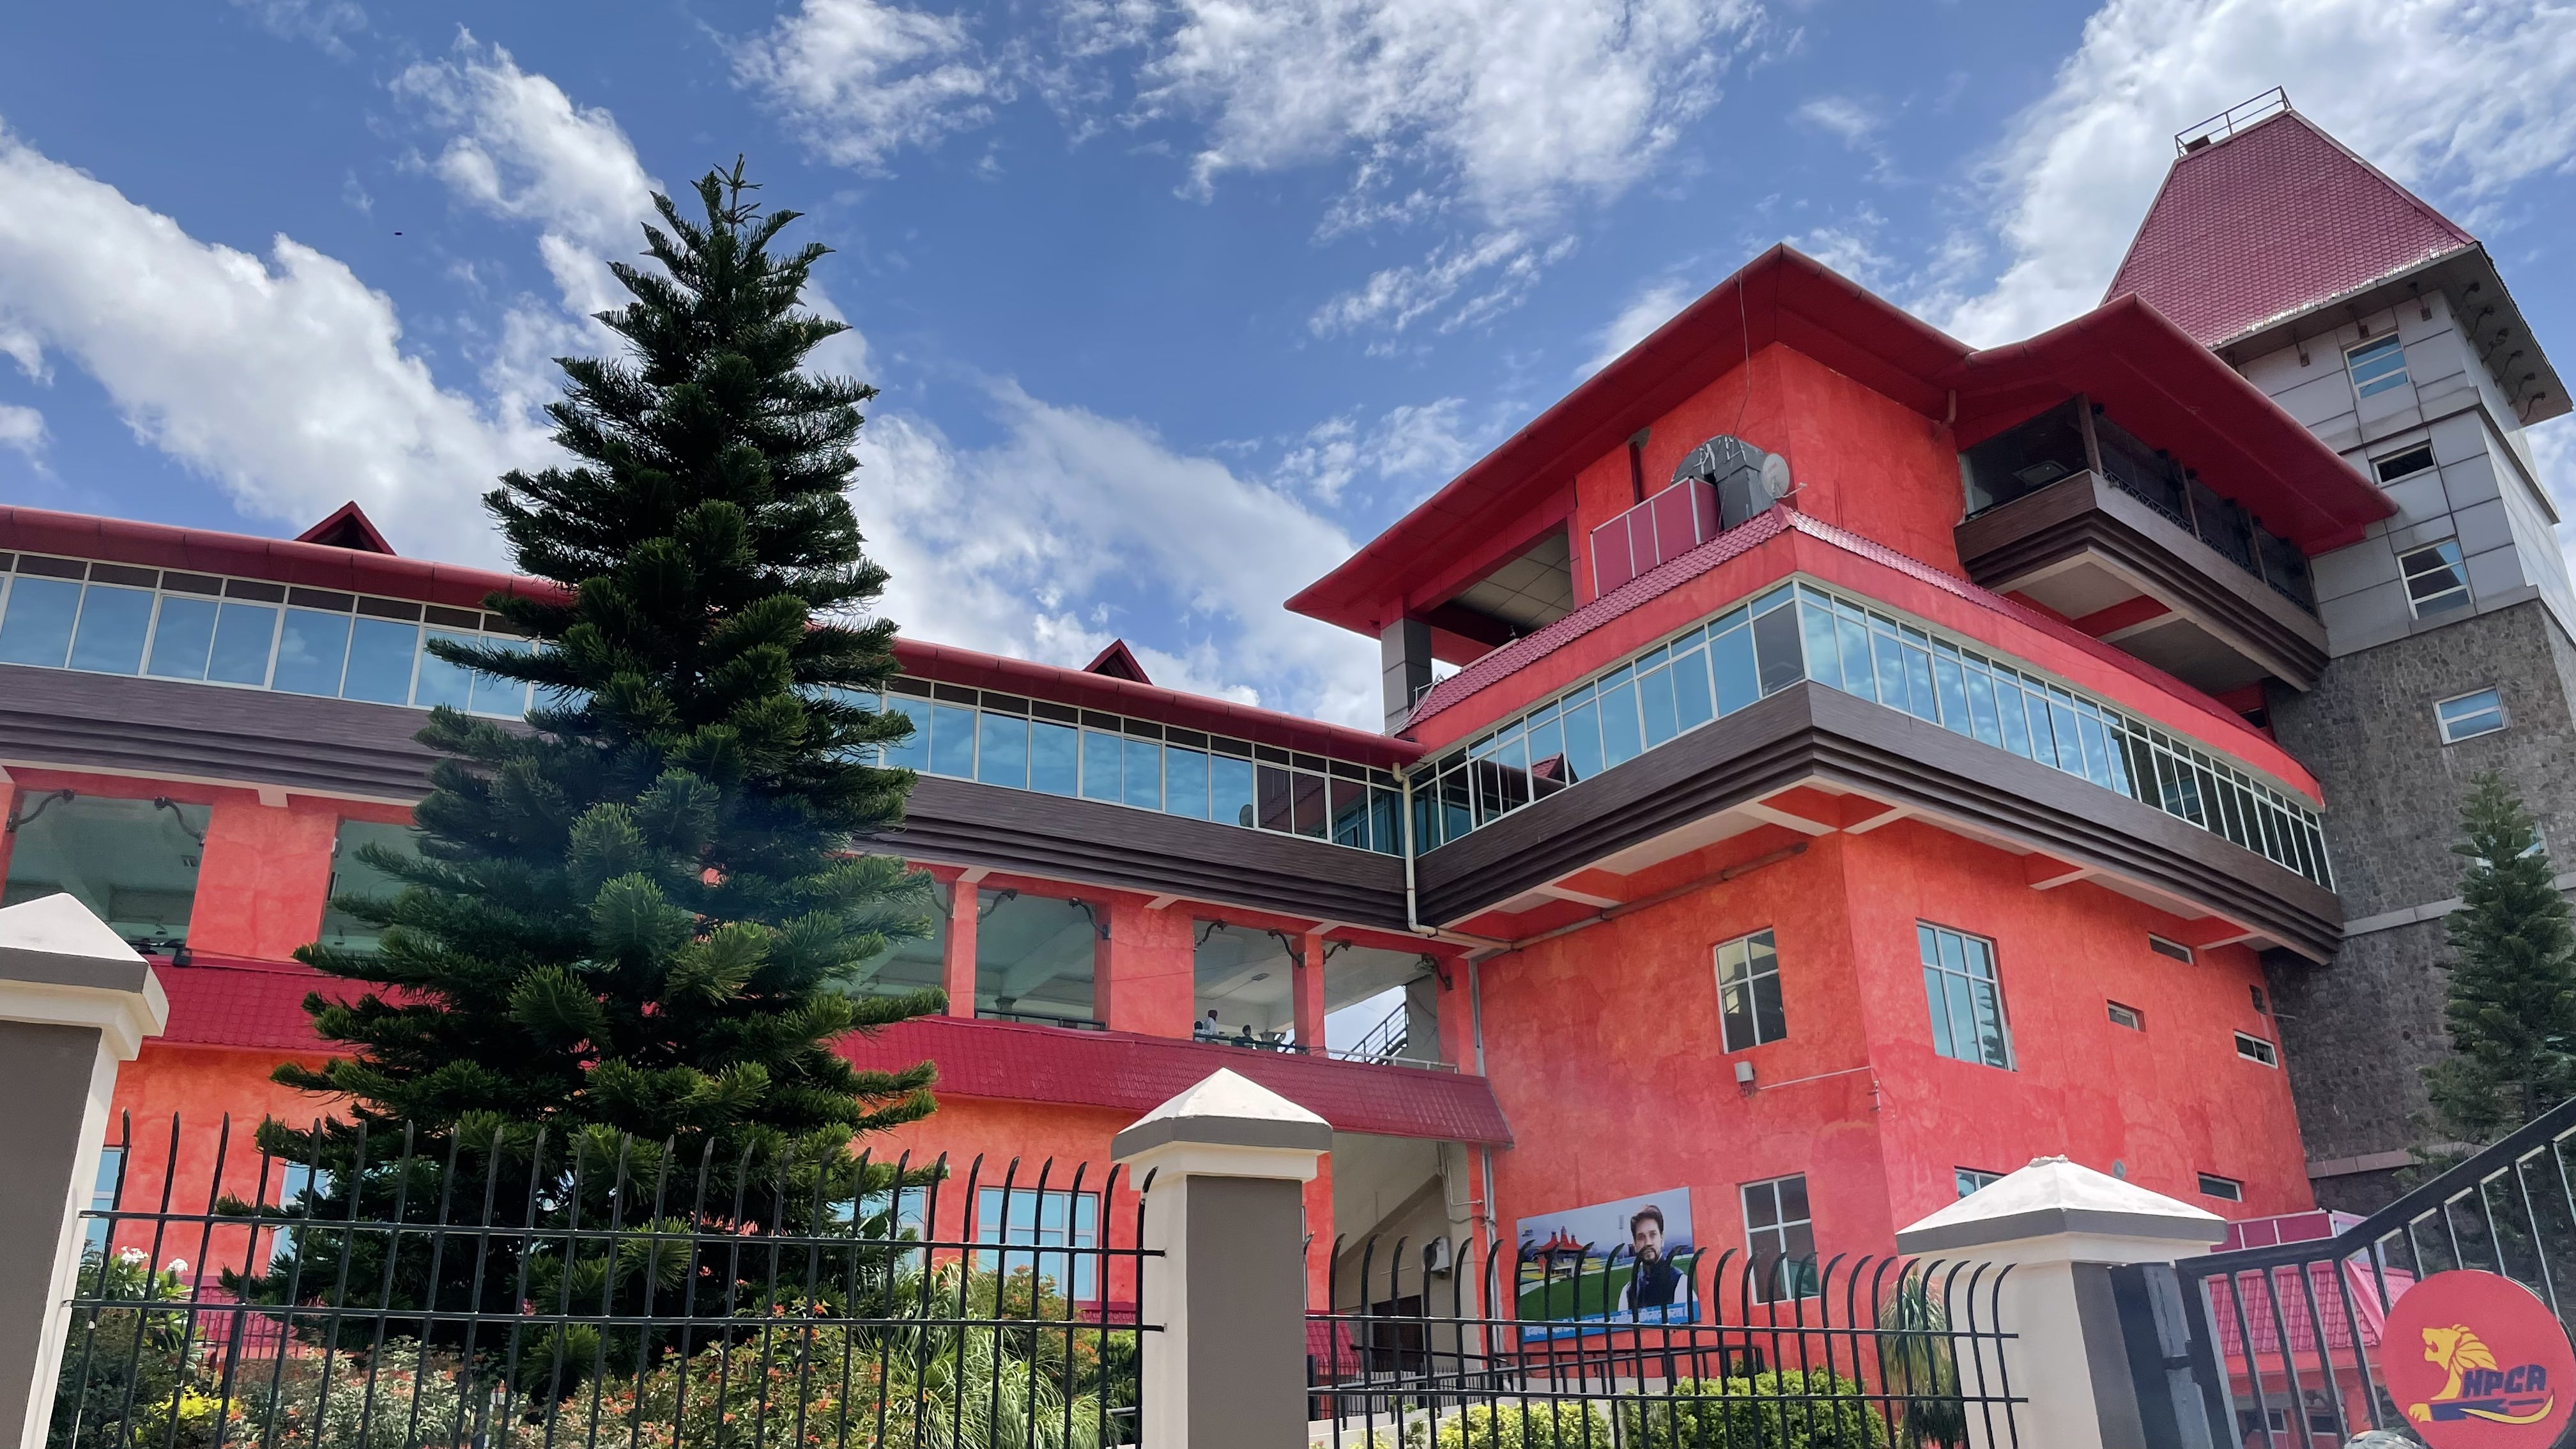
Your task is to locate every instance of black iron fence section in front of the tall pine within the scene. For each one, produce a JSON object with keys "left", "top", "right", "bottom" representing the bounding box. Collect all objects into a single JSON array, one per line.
[{"left": 49, "top": 1121, "right": 1156, "bottom": 1449}]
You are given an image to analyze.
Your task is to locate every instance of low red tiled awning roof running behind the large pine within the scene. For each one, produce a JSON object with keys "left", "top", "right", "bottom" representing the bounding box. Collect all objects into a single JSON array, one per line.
[{"left": 155, "top": 956, "right": 1512, "bottom": 1147}]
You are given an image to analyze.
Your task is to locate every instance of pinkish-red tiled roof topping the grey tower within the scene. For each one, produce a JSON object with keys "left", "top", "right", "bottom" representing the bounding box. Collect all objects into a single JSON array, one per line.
[{"left": 2104, "top": 111, "right": 2478, "bottom": 346}]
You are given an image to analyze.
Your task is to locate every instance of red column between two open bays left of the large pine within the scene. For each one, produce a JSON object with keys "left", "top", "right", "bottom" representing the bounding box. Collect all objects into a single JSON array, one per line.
[{"left": 188, "top": 794, "right": 340, "bottom": 962}]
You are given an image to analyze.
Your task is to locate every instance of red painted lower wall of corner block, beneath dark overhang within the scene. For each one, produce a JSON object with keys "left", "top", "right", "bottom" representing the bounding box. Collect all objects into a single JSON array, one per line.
[{"left": 1478, "top": 822, "right": 2311, "bottom": 1273}]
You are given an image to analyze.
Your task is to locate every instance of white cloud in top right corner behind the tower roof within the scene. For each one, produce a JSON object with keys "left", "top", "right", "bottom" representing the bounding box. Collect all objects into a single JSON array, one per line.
[{"left": 1919, "top": 0, "right": 2576, "bottom": 343}]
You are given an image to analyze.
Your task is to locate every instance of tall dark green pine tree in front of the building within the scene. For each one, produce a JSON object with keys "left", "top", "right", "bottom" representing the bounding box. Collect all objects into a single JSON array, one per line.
[{"left": 226, "top": 162, "right": 943, "bottom": 1361}]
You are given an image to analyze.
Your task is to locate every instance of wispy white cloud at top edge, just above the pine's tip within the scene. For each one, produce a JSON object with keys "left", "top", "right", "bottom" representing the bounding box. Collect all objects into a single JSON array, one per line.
[{"left": 734, "top": 0, "right": 1004, "bottom": 172}]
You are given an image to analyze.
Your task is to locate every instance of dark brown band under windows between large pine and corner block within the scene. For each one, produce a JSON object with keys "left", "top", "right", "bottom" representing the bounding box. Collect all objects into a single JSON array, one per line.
[{"left": 878, "top": 776, "right": 1404, "bottom": 931}]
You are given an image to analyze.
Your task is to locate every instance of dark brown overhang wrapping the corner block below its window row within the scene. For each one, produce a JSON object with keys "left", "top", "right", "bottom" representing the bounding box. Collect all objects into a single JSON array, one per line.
[{"left": 1417, "top": 683, "right": 2344, "bottom": 962}]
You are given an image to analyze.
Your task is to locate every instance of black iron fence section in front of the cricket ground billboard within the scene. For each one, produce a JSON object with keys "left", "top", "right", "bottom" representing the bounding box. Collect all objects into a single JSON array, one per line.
[{"left": 1306, "top": 1240, "right": 2027, "bottom": 1449}]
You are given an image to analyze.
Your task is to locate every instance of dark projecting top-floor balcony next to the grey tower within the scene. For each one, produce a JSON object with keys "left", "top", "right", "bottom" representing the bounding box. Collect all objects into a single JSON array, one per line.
[{"left": 1955, "top": 472, "right": 2326, "bottom": 694}]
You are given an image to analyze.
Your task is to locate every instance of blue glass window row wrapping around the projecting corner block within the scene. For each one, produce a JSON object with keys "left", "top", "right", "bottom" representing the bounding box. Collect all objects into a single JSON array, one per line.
[{"left": 1414, "top": 583, "right": 2334, "bottom": 887}]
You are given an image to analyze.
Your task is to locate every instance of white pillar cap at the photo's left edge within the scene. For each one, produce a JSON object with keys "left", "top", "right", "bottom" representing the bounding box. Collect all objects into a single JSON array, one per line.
[{"left": 0, "top": 894, "right": 170, "bottom": 1062}]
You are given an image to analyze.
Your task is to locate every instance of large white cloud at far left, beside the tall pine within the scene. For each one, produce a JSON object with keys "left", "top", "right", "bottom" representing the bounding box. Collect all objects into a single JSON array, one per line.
[{"left": 0, "top": 129, "right": 549, "bottom": 562}]
